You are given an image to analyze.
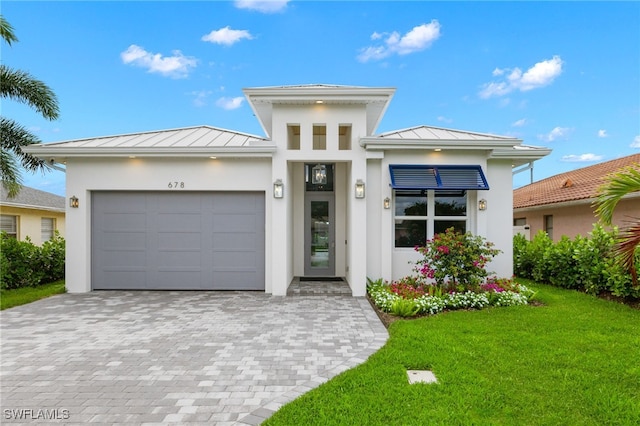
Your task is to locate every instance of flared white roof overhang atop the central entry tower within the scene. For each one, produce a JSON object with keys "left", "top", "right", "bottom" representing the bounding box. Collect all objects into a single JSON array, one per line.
[{"left": 243, "top": 85, "right": 396, "bottom": 137}]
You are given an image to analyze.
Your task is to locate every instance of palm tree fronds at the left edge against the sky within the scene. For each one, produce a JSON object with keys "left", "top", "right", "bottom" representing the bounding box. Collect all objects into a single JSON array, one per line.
[{"left": 0, "top": 15, "right": 59, "bottom": 197}]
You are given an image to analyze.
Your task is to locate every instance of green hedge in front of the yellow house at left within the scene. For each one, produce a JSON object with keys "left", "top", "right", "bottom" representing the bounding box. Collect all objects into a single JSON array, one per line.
[{"left": 0, "top": 231, "right": 65, "bottom": 289}]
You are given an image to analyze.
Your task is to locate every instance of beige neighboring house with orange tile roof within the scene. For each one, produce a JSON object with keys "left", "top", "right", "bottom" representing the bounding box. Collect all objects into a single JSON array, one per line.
[{"left": 513, "top": 154, "right": 640, "bottom": 241}]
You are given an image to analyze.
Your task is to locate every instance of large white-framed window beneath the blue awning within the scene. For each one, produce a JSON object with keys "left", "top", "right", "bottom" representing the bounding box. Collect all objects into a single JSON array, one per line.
[{"left": 394, "top": 190, "right": 467, "bottom": 248}]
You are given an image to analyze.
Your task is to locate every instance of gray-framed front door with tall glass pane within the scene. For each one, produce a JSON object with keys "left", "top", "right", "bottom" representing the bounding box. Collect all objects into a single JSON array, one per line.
[{"left": 304, "top": 192, "right": 336, "bottom": 277}]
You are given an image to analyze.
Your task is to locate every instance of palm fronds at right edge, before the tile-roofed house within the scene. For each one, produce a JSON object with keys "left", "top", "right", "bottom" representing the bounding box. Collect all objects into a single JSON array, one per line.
[{"left": 595, "top": 163, "right": 640, "bottom": 285}]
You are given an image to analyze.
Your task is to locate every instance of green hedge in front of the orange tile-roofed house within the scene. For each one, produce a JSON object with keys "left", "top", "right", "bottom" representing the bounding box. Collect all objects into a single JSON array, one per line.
[{"left": 513, "top": 224, "right": 640, "bottom": 298}]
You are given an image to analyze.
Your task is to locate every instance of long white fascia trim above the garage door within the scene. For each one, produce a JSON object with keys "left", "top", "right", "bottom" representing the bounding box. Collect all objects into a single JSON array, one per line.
[{"left": 23, "top": 145, "right": 276, "bottom": 158}]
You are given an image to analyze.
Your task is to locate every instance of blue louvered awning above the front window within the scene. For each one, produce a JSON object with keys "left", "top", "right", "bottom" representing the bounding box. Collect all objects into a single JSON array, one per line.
[{"left": 389, "top": 164, "right": 489, "bottom": 190}]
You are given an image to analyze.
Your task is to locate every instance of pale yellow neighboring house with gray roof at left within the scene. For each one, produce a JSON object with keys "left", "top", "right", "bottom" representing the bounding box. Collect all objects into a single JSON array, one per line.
[{"left": 0, "top": 185, "right": 65, "bottom": 245}]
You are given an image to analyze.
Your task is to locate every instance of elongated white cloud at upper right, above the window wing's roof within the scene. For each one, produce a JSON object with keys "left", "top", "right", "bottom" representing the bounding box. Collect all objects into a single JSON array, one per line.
[{"left": 478, "top": 55, "right": 564, "bottom": 99}]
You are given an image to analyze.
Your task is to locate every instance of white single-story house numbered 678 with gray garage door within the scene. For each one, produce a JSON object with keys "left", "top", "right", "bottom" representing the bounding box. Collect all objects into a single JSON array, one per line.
[{"left": 25, "top": 85, "right": 550, "bottom": 296}]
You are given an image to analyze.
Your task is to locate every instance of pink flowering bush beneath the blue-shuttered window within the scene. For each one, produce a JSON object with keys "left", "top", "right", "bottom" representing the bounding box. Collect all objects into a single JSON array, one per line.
[{"left": 414, "top": 228, "right": 500, "bottom": 291}]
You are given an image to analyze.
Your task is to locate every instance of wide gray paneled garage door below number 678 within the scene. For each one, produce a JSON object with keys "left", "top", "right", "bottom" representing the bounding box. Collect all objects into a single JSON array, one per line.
[{"left": 91, "top": 192, "right": 265, "bottom": 290}]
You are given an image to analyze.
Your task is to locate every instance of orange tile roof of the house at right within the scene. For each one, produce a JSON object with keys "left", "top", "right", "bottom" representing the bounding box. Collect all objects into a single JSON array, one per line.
[{"left": 513, "top": 154, "right": 640, "bottom": 209}]
